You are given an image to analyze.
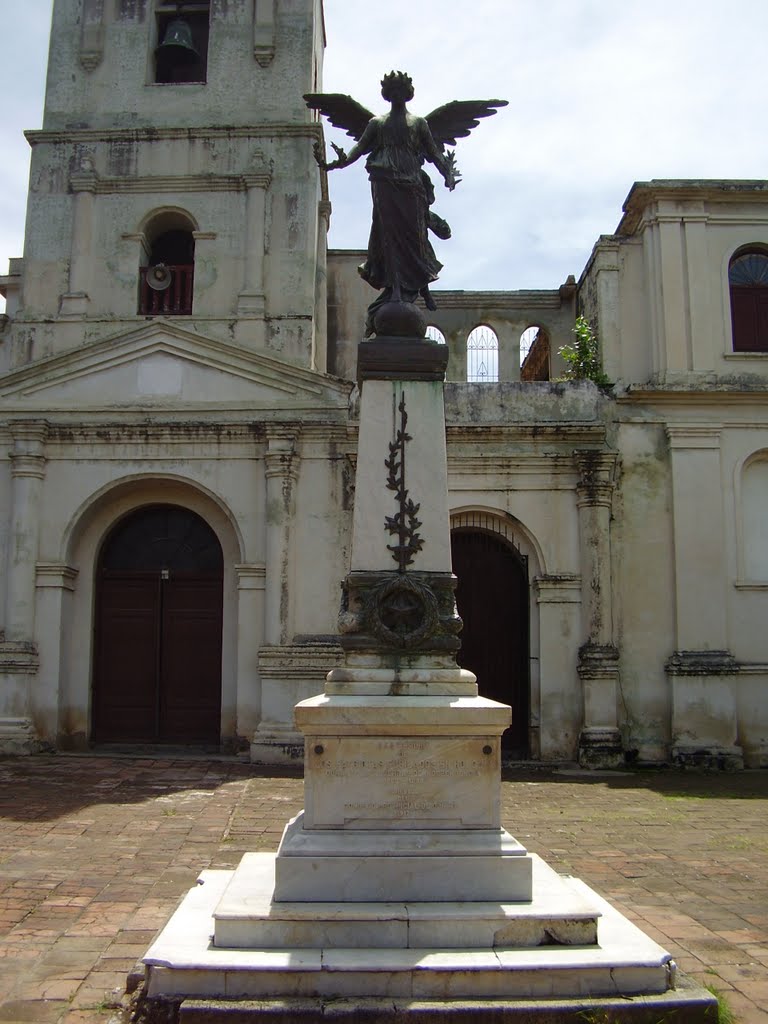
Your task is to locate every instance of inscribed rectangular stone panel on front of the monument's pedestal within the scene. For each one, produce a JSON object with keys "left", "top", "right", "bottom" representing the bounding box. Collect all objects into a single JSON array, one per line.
[{"left": 304, "top": 736, "right": 500, "bottom": 828}]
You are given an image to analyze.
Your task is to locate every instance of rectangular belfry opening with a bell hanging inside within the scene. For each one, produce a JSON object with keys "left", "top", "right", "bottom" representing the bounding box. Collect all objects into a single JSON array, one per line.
[{"left": 155, "top": 0, "right": 210, "bottom": 85}]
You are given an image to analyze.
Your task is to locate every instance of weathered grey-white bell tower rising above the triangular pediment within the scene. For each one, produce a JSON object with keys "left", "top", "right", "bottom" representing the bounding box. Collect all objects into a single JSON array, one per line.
[{"left": 8, "top": 0, "right": 328, "bottom": 370}]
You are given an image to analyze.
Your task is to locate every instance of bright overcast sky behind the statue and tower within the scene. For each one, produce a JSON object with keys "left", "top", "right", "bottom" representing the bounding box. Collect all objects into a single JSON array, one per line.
[{"left": 0, "top": 0, "right": 768, "bottom": 303}]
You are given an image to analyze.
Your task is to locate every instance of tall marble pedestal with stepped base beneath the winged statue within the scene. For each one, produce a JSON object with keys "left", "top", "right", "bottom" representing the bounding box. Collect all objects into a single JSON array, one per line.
[{"left": 144, "top": 321, "right": 714, "bottom": 1024}]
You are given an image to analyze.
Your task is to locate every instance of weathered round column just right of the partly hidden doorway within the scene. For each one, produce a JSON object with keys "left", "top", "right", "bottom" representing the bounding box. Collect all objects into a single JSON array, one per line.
[{"left": 574, "top": 450, "right": 624, "bottom": 768}]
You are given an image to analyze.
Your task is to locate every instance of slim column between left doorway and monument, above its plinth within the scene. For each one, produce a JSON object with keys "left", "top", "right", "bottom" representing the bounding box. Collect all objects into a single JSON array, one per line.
[{"left": 264, "top": 425, "right": 299, "bottom": 645}]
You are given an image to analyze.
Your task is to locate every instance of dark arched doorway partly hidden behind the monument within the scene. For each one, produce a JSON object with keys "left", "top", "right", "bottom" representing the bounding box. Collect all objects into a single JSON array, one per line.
[{"left": 451, "top": 526, "right": 530, "bottom": 759}]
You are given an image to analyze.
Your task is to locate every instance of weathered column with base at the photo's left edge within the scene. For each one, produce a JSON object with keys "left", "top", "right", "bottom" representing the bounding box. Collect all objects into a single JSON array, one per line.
[{"left": 0, "top": 421, "right": 48, "bottom": 754}]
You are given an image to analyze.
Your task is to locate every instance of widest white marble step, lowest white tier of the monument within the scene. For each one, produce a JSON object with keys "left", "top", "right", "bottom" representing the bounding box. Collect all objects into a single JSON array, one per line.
[{"left": 144, "top": 871, "right": 675, "bottom": 1000}]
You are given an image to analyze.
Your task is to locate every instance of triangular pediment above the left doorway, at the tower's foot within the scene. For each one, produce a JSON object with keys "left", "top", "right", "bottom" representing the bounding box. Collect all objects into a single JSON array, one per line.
[{"left": 0, "top": 321, "right": 349, "bottom": 410}]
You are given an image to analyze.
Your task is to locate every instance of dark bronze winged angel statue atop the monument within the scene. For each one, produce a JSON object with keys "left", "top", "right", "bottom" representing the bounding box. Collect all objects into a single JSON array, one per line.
[{"left": 304, "top": 71, "right": 507, "bottom": 337}]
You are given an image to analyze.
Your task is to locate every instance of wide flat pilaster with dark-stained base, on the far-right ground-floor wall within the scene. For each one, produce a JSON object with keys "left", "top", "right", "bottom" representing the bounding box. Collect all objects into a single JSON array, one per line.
[{"left": 667, "top": 423, "right": 743, "bottom": 768}]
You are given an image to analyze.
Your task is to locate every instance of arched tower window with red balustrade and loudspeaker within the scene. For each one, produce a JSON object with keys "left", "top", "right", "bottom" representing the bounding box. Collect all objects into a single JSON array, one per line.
[{"left": 138, "top": 211, "right": 195, "bottom": 316}]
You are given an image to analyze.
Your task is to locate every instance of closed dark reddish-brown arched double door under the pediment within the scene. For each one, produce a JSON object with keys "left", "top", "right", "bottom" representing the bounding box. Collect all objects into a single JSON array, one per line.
[{"left": 91, "top": 505, "right": 223, "bottom": 743}]
